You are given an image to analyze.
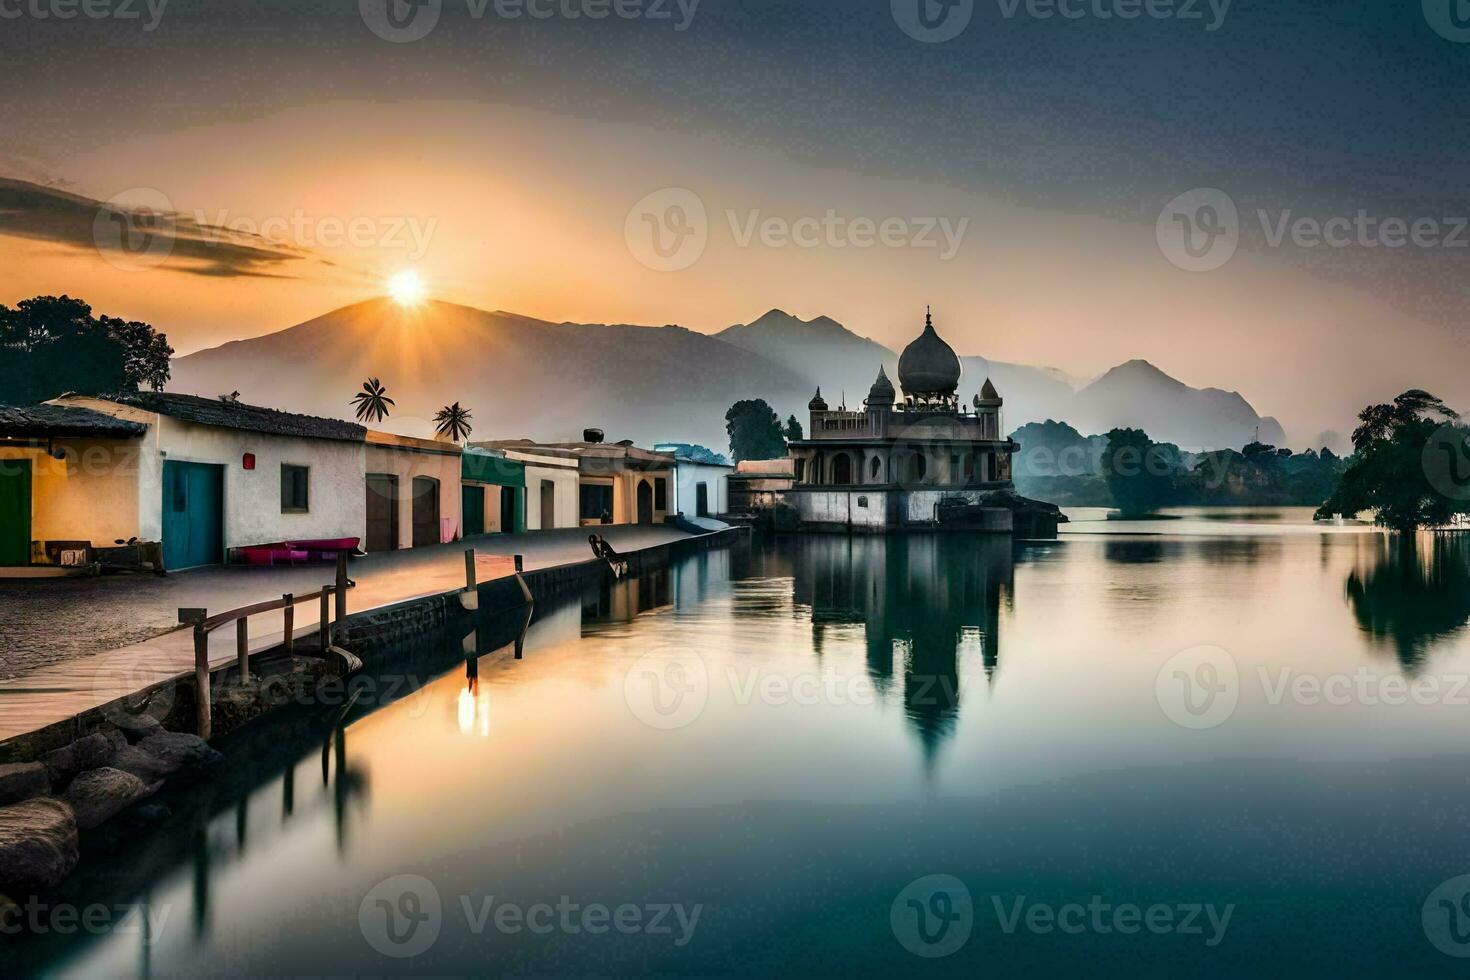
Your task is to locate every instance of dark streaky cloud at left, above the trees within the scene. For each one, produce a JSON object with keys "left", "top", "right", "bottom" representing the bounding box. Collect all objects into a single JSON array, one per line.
[{"left": 0, "top": 178, "right": 318, "bottom": 279}]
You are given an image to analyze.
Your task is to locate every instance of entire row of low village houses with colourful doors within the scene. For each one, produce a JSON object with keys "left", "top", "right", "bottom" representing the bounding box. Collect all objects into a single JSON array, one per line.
[{"left": 0, "top": 392, "right": 732, "bottom": 570}]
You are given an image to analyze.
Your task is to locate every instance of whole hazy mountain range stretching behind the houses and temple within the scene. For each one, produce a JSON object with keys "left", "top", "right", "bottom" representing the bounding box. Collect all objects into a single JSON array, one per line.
[{"left": 169, "top": 300, "right": 1285, "bottom": 451}]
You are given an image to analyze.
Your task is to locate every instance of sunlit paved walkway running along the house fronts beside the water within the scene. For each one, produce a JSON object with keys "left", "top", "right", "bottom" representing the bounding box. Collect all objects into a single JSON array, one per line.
[{"left": 0, "top": 526, "right": 688, "bottom": 742}]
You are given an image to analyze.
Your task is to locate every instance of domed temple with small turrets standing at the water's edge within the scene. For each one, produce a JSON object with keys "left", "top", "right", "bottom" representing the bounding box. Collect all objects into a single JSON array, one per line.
[{"left": 786, "top": 313, "right": 1066, "bottom": 538}]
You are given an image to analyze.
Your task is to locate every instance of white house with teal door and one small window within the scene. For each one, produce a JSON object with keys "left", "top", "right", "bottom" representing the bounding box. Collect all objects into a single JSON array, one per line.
[{"left": 50, "top": 392, "right": 366, "bottom": 570}]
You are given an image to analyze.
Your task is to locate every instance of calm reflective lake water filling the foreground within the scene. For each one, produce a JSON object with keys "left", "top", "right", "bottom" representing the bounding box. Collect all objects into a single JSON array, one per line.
[{"left": 8, "top": 510, "right": 1470, "bottom": 976}]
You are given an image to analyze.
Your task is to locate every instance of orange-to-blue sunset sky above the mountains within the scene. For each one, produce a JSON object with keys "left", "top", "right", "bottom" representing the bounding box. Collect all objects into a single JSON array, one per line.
[{"left": 0, "top": 0, "right": 1470, "bottom": 433}]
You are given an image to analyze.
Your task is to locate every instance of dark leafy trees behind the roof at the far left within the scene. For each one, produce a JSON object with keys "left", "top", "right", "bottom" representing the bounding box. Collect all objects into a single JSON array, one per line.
[{"left": 0, "top": 295, "right": 173, "bottom": 404}]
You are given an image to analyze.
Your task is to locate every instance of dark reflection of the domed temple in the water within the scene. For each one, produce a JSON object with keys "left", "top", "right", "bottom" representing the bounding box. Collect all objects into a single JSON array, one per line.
[{"left": 794, "top": 535, "right": 1013, "bottom": 760}]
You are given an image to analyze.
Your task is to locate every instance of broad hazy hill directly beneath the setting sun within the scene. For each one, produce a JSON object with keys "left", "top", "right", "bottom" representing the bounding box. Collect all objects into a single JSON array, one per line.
[{"left": 169, "top": 300, "right": 811, "bottom": 450}]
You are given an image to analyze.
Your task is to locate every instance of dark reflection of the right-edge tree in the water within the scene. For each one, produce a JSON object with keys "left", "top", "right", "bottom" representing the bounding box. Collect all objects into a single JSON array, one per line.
[{"left": 1347, "top": 535, "right": 1470, "bottom": 670}]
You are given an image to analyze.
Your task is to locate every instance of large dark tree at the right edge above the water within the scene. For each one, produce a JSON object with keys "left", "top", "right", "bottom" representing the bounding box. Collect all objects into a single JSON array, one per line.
[{"left": 1317, "top": 389, "right": 1470, "bottom": 530}]
